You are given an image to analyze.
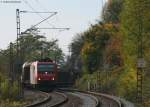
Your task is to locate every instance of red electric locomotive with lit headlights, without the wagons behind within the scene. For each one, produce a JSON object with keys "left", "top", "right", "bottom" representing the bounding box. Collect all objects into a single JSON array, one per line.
[{"left": 21, "top": 60, "right": 58, "bottom": 87}]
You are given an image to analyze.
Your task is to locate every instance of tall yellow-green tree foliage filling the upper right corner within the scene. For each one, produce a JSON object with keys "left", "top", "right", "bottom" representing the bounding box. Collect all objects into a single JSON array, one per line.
[{"left": 121, "top": 0, "right": 150, "bottom": 56}]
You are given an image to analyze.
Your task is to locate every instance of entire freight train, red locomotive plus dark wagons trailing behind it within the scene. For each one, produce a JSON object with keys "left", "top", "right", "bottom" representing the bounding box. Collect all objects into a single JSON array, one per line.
[{"left": 21, "top": 59, "right": 74, "bottom": 88}]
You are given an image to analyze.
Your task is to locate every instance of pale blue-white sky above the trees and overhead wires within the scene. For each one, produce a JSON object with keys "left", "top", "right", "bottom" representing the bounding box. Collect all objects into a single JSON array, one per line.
[{"left": 0, "top": 0, "right": 105, "bottom": 54}]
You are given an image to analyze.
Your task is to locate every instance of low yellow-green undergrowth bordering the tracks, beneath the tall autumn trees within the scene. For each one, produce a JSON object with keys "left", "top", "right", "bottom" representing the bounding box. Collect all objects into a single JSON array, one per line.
[{"left": 75, "top": 69, "right": 150, "bottom": 107}]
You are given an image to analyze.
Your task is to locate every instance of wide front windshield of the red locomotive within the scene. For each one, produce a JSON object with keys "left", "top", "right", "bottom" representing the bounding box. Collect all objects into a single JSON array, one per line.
[{"left": 38, "top": 64, "right": 54, "bottom": 72}]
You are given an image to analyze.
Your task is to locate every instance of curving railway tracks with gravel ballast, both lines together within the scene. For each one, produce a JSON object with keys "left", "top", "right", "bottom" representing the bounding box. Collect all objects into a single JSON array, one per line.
[{"left": 24, "top": 89, "right": 134, "bottom": 107}]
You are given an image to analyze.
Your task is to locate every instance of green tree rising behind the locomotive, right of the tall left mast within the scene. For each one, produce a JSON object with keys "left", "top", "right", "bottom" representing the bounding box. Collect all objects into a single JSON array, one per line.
[{"left": 19, "top": 33, "right": 63, "bottom": 61}]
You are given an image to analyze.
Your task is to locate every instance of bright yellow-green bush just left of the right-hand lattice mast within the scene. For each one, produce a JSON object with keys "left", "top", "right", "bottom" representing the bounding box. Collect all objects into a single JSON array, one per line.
[{"left": 116, "top": 68, "right": 136, "bottom": 101}]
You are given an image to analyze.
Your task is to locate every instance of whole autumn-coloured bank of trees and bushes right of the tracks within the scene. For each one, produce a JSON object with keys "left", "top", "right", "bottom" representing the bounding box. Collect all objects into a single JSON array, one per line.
[{"left": 68, "top": 0, "right": 150, "bottom": 107}]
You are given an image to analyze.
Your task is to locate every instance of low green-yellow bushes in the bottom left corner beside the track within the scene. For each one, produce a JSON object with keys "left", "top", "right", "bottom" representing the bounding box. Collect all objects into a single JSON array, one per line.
[{"left": 0, "top": 74, "right": 30, "bottom": 107}]
